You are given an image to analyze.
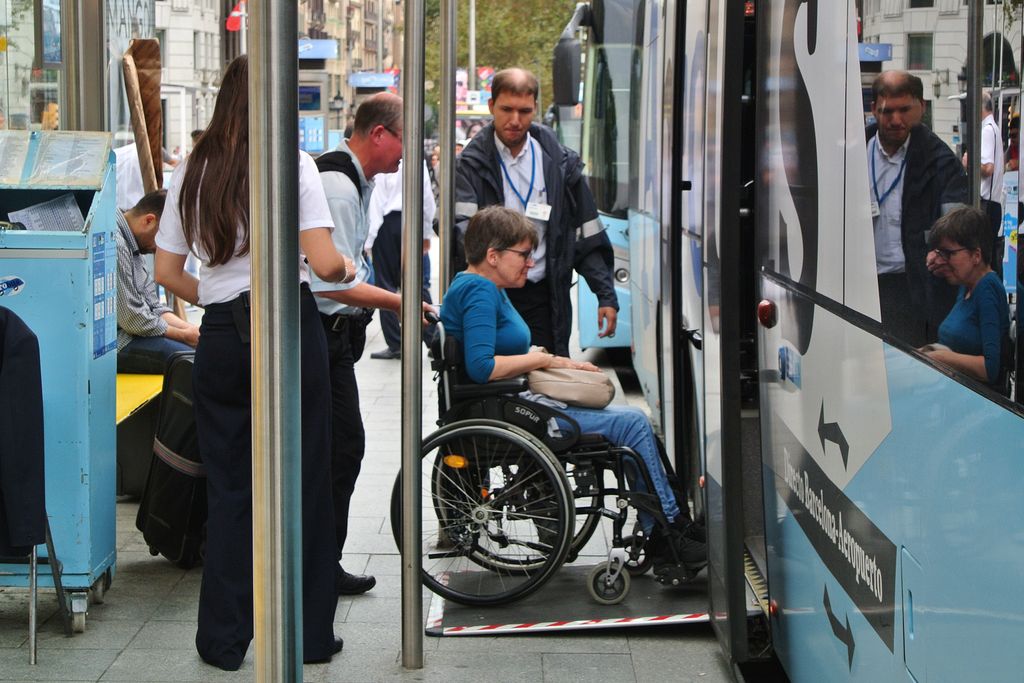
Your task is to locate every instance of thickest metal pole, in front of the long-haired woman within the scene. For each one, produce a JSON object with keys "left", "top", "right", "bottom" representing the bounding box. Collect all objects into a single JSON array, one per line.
[{"left": 249, "top": 0, "right": 302, "bottom": 683}]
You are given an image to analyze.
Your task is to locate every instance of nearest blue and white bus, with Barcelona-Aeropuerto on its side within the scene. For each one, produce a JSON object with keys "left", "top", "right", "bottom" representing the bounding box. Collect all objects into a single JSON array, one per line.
[{"left": 555, "top": 0, "right": 1024, "bottom": 681}]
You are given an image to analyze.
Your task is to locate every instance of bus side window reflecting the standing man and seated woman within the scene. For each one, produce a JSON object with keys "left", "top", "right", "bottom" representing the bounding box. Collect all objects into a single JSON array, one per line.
[{"left": 860, "top": 5, "right": 1021, "bottom": 391}]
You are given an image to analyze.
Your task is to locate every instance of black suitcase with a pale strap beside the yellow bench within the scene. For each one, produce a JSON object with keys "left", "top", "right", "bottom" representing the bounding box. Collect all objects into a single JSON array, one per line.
[{"left": 135, "top": 351, "right": 207, "bottom": 569}]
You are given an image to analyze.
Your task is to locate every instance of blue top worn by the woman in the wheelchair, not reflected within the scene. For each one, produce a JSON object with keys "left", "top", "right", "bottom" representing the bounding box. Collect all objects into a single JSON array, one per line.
[{"left": 441, "top": 272, "right": 529, "bottom": 384}]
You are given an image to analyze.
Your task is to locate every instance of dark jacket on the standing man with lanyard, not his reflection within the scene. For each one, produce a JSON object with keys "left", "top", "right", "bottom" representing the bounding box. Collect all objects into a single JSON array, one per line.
[{"left": 450, "top": 124, "right": 618, "bottom": 355}]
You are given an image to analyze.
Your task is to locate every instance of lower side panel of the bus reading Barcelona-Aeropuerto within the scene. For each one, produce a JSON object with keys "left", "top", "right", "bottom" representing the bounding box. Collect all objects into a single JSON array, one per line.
[{"left": 761, "top": 279, "right": 1024, "bottom": 681}]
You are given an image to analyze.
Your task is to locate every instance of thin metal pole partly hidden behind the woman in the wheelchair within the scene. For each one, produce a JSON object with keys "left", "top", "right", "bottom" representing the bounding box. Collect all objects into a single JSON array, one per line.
[{"left": 437, "top": 0, "right": 458, "bottom": 301}]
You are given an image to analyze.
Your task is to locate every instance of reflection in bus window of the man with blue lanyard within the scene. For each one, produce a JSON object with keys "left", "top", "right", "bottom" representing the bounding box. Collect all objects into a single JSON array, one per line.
[{"left": 867, "top": 71, "right": 967, "bottom": 346}]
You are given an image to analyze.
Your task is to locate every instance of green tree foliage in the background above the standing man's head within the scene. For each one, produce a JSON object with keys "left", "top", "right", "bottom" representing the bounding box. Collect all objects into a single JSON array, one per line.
[{"left": 424, "top": 0, "right": 577, "bottom": 112}]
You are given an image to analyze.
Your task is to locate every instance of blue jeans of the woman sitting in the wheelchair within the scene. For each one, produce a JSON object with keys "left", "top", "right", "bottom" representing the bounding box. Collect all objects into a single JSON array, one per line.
[{"left": 562, "top": 405, "right": 680, "bottom": 533}]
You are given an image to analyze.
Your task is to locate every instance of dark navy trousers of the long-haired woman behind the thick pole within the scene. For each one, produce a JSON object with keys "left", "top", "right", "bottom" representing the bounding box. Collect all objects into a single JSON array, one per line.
[{"left": 193, "top": 286, "right": 338, "bottom": 671}]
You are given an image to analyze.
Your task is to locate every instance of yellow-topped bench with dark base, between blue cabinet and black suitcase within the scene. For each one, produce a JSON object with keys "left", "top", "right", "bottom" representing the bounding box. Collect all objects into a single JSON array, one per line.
[{"left": 116, "top": 373, "right": 164, "bottom": 496}]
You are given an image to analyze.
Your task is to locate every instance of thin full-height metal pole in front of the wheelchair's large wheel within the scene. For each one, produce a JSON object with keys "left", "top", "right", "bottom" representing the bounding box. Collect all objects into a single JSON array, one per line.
[{"left": 401, "top": 0, "right": 424, "bottom": 669}]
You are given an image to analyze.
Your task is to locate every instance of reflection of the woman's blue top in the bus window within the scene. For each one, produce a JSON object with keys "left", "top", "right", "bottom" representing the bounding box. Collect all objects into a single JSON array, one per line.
[{"left": 939, "top": 272, "right": 1010, "bottom": 383}]
